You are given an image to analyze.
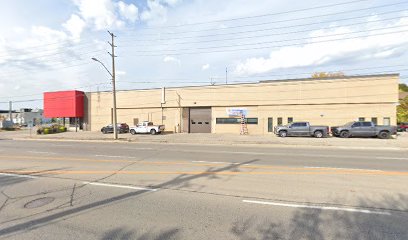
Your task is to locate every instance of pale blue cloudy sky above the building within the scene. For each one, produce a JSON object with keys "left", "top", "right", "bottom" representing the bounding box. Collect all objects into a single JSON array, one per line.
[{"left": 0, "top": 0, "right": 408, "bottom": 109}]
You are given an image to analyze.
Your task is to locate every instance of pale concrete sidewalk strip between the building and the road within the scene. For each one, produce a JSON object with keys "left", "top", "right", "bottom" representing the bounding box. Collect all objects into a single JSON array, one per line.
[{"left": 0, "top": 130, "right": 408, "bottom": 150}]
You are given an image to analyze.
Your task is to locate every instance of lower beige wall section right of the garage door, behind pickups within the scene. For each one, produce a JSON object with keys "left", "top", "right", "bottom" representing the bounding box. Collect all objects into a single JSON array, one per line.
[{"left": 212, "top": 104, "right": 396, "bottom": 134}]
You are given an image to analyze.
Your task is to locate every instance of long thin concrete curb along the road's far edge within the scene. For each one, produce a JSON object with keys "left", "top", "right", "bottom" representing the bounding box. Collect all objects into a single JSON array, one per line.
[{"left": 10, "top": 138, "right": 408, "bottom": 151}]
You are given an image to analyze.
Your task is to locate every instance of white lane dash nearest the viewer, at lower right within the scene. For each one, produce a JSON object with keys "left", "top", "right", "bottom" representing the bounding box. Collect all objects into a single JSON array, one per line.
[{"left": 242, "top": 200, "right": 391, "bottom": 215}]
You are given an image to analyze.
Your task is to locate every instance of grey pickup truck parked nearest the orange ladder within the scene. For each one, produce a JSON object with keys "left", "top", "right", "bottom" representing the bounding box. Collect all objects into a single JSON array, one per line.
[{"left": 275, "top": 122, "right": 329, "bottom": 138}]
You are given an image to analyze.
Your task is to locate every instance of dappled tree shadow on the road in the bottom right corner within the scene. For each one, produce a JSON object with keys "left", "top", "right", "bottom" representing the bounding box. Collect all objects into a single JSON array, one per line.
[{"left": 230, "top": 196, "right": 408, "bottom": 240}]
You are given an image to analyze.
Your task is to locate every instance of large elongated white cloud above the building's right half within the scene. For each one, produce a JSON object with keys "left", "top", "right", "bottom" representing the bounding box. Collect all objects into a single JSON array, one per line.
[{"left": 235, "top": 18, "right": 408, "bottom": 75}]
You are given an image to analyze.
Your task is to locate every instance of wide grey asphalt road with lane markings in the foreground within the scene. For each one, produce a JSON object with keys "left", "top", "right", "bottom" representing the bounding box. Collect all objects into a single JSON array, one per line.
[{"left": 0, "top": 140, "right": 408, "bottom": 240}]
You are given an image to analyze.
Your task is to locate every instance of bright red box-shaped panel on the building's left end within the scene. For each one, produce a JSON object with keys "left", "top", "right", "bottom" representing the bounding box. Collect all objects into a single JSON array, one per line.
[{"left": 44, "top": 91, "right": 85, "bottom": 118}]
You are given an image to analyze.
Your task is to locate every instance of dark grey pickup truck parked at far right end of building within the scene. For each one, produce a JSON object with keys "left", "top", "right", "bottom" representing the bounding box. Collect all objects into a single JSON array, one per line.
[{"left": 331, "top": 122, "right": 397, "bottom": 139}]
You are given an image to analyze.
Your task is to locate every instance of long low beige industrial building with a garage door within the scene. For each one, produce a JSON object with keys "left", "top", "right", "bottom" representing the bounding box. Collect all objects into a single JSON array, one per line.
[{"left": 83, "top": 74, "right": 399, "bottom": 134}]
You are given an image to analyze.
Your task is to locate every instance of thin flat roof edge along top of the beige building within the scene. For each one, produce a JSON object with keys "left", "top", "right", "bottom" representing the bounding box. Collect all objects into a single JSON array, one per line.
[{"left": 87, "top": 73, "right": 400, "bottom": 93}]
